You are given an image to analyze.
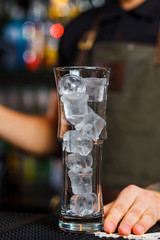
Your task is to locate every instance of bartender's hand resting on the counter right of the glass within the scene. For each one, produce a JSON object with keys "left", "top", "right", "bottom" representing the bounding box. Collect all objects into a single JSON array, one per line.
[{"left": 104, "top": 185, "right": 160, "bottom": 235}]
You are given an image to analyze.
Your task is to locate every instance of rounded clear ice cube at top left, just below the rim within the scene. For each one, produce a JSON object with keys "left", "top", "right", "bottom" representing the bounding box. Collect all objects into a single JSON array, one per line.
[{"left": 59, "top": 74, "right": 86, "bottom": 95}]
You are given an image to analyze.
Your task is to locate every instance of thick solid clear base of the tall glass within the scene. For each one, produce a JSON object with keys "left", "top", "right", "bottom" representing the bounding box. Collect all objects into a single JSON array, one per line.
[{"left": 59, "top": 217, "right": 103, "bottom": 233}]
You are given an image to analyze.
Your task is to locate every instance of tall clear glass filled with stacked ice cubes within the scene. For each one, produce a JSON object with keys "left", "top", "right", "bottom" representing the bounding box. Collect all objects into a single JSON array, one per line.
[{"left": 54, "top": 67, "right": 110, "bottom": 232}]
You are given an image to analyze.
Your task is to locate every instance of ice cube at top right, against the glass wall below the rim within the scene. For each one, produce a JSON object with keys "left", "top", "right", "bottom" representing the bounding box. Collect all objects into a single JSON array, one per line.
[{"left": 84, "top": 78, "right": 107, "bottom": 102}]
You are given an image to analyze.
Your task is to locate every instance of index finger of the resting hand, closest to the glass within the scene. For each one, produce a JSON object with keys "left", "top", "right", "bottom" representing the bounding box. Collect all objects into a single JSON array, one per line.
[{"left": 104, "top": 185, "right": 139, "bottom": 233}]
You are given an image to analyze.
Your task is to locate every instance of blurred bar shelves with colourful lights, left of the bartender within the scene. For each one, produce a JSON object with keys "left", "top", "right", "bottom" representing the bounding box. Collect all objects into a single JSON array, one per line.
[{"left": 0, "top": 0, "right": 104, "bottom": 212}]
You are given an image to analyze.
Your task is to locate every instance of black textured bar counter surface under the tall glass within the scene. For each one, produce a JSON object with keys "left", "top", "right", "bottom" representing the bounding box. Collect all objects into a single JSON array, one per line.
[{"left": 0, "top": 211, "right": 160, "bottom": 240}]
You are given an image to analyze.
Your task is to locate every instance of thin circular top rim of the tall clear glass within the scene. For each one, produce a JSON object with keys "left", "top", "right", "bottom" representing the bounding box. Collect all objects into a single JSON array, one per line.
[{"left": 53, "top": 66, "right": 111, "bottom": 73}]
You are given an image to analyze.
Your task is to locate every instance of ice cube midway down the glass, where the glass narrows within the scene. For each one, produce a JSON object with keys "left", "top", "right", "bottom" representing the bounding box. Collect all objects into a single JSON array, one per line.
[{"left": 62, "top": 130, "right": 93, "bottom": 156}]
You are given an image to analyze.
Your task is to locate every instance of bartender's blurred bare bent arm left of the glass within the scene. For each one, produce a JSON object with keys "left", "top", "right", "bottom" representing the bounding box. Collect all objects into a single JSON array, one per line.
[{"left": 0, "top": 90, "right": 59, "bottom": 154}]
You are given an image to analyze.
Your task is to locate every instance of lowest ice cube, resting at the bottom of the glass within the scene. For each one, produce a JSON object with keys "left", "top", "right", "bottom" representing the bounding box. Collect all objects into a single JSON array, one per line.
[{"left": 70, "top": 193, "right": 98, "bottom": 217}]
